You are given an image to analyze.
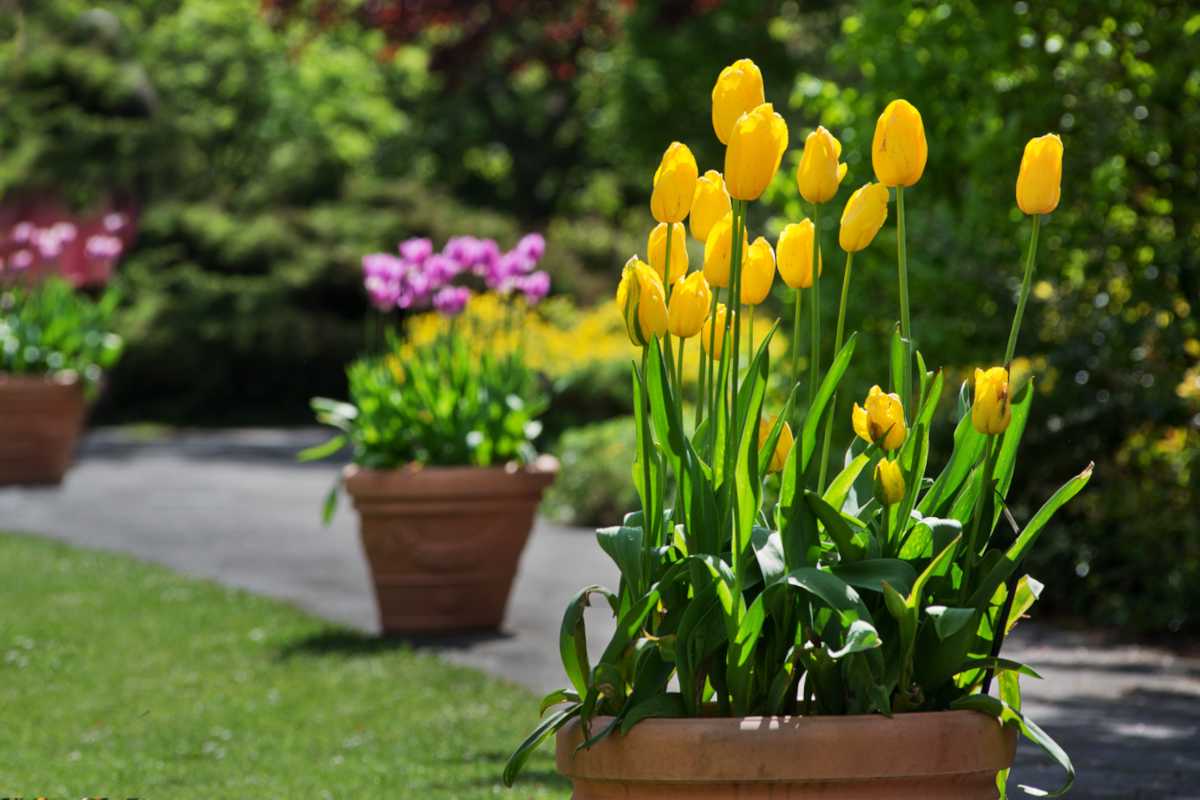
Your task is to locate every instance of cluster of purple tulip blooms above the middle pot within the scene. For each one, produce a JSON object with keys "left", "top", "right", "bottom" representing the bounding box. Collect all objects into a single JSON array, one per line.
[{"left": 362, "top": 233, "right": 550, "bottom": 317}]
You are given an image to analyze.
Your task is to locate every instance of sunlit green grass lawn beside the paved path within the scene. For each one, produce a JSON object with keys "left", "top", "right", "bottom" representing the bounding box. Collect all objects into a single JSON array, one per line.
[{"left": 0, "top": 535, "right": 569, "bottom": 800}]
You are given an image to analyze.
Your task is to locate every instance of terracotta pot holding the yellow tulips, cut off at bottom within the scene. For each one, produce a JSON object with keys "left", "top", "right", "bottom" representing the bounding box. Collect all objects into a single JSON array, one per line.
[{"left": 558, "top": 711, "right": 1016, "bottom": 800}]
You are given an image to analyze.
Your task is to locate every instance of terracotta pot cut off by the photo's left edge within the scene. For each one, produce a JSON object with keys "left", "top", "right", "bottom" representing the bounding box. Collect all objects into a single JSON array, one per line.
[{"left": 0, "top": 373, "right": 86, "bottom": 486}]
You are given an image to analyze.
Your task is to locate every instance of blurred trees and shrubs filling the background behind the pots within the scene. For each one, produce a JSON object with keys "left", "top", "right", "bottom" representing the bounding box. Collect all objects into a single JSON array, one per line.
[{"left": 0, "top": 0, "right": 1200, "bottom": 633}]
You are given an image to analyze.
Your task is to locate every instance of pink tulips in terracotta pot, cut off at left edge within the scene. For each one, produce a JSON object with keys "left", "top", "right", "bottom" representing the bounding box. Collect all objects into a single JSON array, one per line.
[{"left": 0, "top": 212, "right": 127, "bottom": 486}]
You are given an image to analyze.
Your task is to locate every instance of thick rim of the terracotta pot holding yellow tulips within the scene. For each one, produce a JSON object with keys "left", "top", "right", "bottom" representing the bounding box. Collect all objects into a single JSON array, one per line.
[{"left": 557, "top": 710, "right": 1016, "bottom": 783}]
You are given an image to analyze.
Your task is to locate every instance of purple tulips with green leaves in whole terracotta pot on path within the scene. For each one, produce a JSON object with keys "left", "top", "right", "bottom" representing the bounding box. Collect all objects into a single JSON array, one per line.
[{"left": 301, "top": 234, "right": 558, "bottom": 633}]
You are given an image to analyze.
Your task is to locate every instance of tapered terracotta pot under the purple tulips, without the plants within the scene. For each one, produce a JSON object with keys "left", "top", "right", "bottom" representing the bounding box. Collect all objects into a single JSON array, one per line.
[{"left": 346, "top": 457, "right": 558, "bottom": 633}]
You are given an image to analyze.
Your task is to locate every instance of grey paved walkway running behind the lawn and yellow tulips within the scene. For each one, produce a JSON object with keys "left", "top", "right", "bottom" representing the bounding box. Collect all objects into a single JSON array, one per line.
[{"left": 0, "top": 431, "right": 1200, "bottom": 799}]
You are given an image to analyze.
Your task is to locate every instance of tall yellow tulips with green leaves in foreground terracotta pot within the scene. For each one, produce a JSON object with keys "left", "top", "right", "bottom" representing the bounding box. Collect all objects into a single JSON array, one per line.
[{"left": 504, "top": 60, "right": 1091, "bottom": 800}]
